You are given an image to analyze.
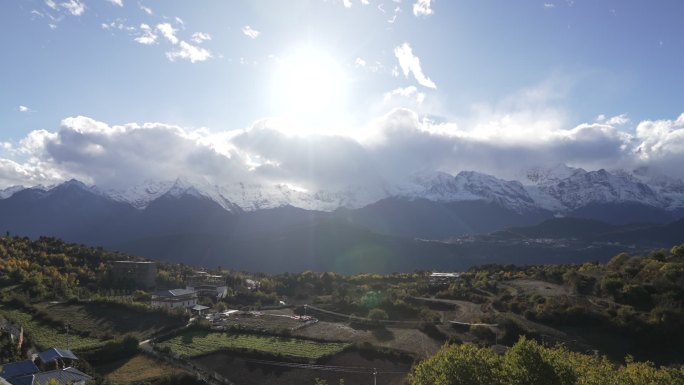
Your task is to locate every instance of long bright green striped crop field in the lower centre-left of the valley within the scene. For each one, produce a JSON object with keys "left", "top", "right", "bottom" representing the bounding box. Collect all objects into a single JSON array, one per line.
[{"left": 159, "top": 330, "right": 350, "bottom": 359}]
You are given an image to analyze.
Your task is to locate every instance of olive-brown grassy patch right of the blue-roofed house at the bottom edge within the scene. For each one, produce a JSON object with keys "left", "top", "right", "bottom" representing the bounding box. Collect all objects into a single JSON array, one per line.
[{"left": 96, "top": 354, "right": 184, "bottom": 384}]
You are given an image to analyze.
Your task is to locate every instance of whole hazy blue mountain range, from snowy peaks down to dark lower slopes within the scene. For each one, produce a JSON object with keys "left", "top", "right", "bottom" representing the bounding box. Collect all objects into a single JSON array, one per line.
[{"left": 0, "top": 165, "right": 684, "bottom": 272}]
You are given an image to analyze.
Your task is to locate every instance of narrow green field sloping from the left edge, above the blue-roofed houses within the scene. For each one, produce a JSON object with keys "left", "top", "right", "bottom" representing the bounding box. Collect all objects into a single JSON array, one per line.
[{"left": 0, "top": 305, "right": 102, "bottom": 350}]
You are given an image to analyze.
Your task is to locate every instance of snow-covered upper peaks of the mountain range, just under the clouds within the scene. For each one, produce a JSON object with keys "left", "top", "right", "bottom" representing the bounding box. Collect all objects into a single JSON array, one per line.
[{"left": 0, "top": 165, "right": 684, "bottom": 215}]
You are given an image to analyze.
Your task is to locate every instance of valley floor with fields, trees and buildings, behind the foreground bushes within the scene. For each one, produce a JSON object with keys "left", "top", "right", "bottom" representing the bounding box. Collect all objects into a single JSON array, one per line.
[{"left": 0, "top": 237, "right": 684, "bottom": 385}]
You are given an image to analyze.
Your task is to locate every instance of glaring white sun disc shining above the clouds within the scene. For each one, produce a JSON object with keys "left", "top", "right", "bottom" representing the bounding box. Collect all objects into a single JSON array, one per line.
[{"left": 271, "top": 47, "right": 348, "bottom": 134}]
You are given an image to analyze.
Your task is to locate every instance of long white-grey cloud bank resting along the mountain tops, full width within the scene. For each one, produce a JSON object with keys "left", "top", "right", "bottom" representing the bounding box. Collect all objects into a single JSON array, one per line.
[{"left": 0, "top": 109, "right": 684, "bottom": 189}]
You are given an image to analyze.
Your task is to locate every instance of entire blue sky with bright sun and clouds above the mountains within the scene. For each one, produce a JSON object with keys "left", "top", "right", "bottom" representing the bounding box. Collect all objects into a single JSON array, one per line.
[{"left": 0, "top": 0, "right": 684, "bottom": 189}]
